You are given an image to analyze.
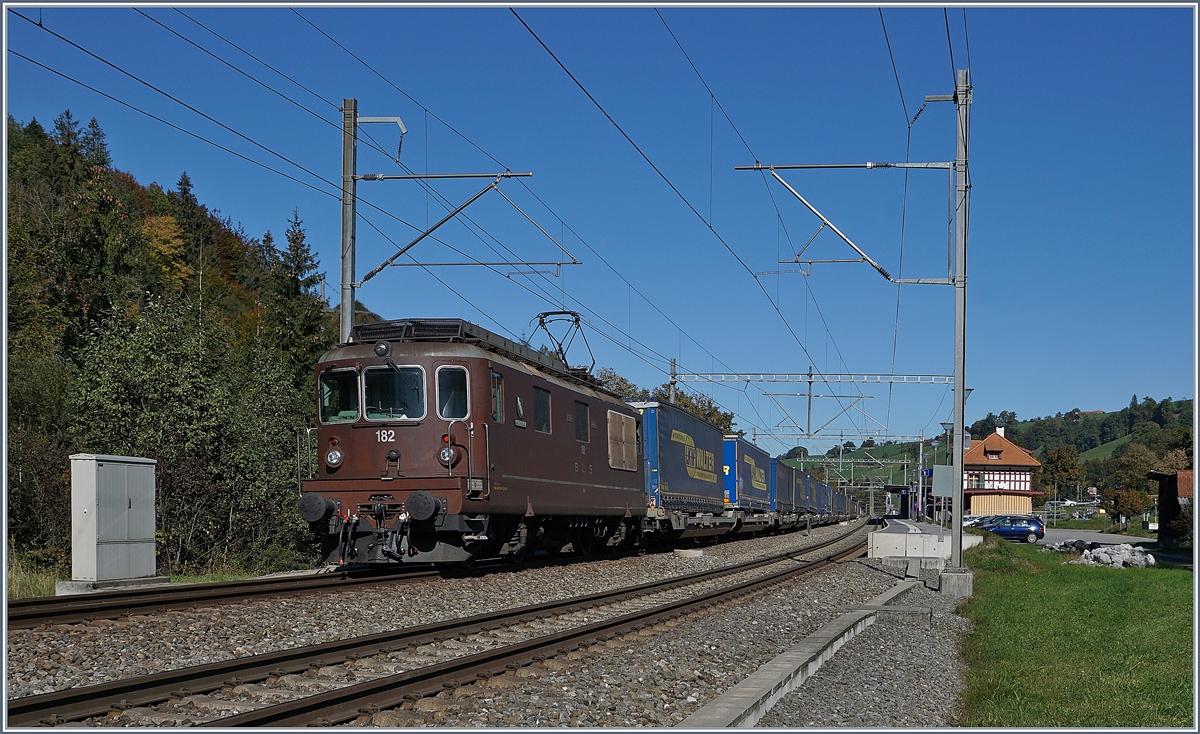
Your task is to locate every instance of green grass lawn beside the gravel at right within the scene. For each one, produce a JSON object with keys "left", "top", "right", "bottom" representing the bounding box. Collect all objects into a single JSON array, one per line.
[{"left": 962, "top": 537, "right": 1195, "bottom": 728}]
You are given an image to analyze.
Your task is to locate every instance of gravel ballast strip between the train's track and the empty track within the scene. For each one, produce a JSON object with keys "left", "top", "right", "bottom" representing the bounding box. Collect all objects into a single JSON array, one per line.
[{"left": 7, "top": 525, "right": 864, "bottom": 698}]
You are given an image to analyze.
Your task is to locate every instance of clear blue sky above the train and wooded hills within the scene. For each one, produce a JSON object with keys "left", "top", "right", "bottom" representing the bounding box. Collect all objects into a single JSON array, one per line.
[{"left": 5, "top": 2, "right": 1195, "bottom": 452}]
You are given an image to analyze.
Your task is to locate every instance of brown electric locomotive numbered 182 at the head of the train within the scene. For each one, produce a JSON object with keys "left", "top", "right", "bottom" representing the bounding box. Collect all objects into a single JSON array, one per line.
[{"left": 299, "top": 319, "right": 647, "bottom": 565}]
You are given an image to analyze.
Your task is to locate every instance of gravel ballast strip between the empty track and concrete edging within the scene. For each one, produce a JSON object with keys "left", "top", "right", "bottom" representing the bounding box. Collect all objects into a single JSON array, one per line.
[{"left": 354, "top": 561, "right": 895, "bottom": 727}]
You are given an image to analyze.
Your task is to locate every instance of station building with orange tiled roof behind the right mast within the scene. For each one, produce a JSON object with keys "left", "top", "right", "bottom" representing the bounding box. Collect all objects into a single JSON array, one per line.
[{"left": 962, "top": 427, "right": 1044, "bottom": 516}]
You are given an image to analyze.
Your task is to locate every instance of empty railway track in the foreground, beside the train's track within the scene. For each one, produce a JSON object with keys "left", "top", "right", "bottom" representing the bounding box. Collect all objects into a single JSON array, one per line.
[{"left": 8, "top": 529, "right": 862, "bottom": 727}]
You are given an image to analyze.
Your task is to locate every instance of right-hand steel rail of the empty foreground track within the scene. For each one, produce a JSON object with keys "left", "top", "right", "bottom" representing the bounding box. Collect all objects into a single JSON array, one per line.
[{"left": 213, "top": 539, "right": 866, "bottom": 728}]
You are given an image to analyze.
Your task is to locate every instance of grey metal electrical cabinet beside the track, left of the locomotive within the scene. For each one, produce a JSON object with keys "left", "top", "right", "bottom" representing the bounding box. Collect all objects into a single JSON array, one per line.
[{"left": 71, "top": 453, "right": 157, "bottom": 582}]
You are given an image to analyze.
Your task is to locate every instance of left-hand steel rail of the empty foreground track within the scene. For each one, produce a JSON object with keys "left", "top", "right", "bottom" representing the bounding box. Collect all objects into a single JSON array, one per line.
[{"left": 7, "top": 527, "right": 860, "bottom": 727}]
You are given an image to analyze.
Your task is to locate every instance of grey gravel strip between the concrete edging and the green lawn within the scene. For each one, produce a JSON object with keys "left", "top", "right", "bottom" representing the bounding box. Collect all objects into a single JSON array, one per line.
[{"left": 757, "top": 561, "right": 971, "bottom": 728}]
